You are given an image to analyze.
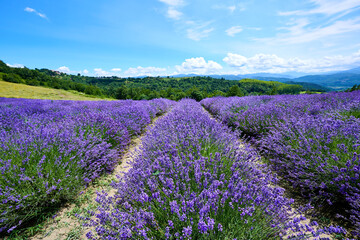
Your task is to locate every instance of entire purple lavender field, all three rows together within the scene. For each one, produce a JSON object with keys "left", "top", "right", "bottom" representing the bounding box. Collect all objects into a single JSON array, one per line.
[{"left": 0, "top": 91, "right": 360, "bottom": 239}]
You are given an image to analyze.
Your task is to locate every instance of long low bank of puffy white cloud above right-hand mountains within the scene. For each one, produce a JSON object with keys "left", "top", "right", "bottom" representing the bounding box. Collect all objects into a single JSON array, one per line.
[{"left": 223, "top": 51, "right": 360, "bottom": 74}]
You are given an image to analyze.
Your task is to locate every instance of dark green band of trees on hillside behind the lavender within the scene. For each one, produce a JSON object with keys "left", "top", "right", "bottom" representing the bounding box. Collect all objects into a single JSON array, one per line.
[{"left": 0, "top": 61, "right": 304, "bottom": 101}]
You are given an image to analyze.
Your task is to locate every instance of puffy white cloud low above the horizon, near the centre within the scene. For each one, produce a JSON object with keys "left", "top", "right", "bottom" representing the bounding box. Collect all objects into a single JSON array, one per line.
[{"left": 175, "top": 57, "right": 222, "bottom": 74}]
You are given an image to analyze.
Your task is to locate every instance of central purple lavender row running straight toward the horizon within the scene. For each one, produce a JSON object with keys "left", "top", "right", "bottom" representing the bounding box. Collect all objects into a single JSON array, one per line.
[{"left": 87, "top": 100, "right": 342, "bottom": 239}]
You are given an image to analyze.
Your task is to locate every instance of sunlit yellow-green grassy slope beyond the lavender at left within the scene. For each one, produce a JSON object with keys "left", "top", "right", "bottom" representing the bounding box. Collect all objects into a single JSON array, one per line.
[{"left": 0, "top": 78, "right": 110, "bottom": 101}]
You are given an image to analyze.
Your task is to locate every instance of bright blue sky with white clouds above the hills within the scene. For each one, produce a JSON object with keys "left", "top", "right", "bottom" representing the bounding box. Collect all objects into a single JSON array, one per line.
[{"left": 0, "top": 0, "right": 360, "bottom": 77}]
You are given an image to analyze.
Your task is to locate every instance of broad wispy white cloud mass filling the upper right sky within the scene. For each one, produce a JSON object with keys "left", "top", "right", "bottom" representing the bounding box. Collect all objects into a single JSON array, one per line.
[{"left": 268, "top": 0, "right": 360, "bottom": 45}]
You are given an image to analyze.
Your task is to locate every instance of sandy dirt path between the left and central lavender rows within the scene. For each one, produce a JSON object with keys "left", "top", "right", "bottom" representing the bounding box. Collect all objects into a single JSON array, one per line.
[{"left": 30, "top": 114, "right": 166, "bottom": 240}]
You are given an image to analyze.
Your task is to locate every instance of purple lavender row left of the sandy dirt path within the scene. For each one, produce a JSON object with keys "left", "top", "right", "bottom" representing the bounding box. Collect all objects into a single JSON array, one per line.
[{"left": 0, "top": 98, "right": 172, "bottom": 234}]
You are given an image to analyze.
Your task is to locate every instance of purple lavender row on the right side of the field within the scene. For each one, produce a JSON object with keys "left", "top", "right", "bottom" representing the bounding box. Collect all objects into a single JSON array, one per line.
[{"left": 201, "top": 91, "right": 360, "bottom": 235}]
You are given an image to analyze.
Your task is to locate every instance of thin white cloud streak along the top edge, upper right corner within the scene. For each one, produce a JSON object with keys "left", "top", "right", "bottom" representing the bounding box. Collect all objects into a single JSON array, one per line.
[{"left": 279, "top": 0, "right": 360, "bottom": 16}]
